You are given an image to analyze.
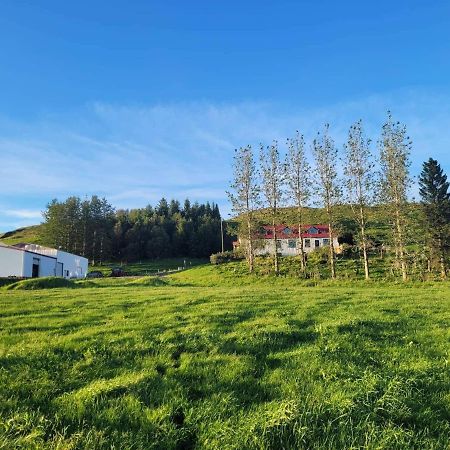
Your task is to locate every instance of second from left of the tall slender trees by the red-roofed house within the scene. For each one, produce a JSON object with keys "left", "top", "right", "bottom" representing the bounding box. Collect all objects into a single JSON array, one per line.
[{"left": 260, "top": 141, "right": 284, "bottom": 274}]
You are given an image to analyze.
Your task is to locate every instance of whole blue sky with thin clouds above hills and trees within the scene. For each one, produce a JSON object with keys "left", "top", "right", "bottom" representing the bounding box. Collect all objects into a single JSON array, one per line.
[{"left": 0, "top": 0, "right": 450, "bottom": 231}]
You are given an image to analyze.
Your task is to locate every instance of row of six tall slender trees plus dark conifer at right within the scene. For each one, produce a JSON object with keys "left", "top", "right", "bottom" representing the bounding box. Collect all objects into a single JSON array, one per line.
[{"left": 229, "top": 112, "right": 450, "bottom": 280}]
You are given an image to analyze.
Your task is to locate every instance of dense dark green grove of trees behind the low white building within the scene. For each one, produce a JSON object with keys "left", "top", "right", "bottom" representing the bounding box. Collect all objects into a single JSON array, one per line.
[{"left": 42, "top": 196, "right": 225, "bottom": 263}]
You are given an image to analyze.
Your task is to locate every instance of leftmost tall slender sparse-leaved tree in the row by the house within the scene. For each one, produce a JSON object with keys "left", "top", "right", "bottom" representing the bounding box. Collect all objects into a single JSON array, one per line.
[{"left": 227, "top": 145, "right": 260, "bottom": 272}]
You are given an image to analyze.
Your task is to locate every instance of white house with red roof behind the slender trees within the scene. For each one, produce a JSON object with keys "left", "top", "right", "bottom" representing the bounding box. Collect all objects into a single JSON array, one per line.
[{"left": 235, "top": 225, "right": 340, "bottom": 256}]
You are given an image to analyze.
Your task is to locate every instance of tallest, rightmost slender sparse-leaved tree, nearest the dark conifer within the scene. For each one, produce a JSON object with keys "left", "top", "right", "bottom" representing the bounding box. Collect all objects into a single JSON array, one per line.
[{"left": 379, "top": 111, "right": 411, "bottom": 281}]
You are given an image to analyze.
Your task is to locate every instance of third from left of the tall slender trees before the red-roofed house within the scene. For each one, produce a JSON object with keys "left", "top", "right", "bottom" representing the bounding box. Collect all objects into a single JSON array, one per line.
[{"left": 285, "top": 131, "right": 311, "bottom": 273}]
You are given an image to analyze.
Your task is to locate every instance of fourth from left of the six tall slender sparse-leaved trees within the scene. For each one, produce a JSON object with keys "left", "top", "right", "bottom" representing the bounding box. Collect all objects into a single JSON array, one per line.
[{"left": 313, "top": 124, "right": 340, "bottom": 278}]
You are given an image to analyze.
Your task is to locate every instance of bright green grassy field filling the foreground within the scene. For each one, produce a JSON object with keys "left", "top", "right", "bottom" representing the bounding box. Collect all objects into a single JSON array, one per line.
[{"left": 0, "top": 266, "right": 450, "bottom": 449}]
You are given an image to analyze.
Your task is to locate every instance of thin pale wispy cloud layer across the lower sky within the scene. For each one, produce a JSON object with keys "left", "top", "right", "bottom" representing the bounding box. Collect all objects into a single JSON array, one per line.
[{"left": 0, "top": 90, "right": 450, "bottom": 230}]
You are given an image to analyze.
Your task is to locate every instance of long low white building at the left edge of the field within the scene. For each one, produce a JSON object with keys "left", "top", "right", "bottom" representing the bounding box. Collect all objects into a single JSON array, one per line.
[{"left": 0, "top": 244, "right": 88, "bottom": 278}]
